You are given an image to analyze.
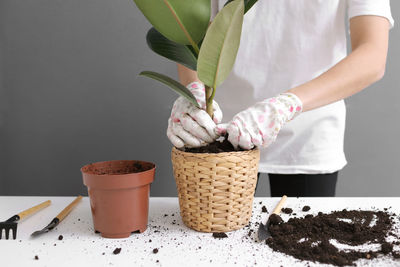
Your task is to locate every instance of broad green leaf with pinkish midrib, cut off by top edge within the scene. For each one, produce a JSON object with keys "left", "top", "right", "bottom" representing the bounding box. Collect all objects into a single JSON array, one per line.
[{"left": 134, "top": 0, "right": 211, "bottom": 53}]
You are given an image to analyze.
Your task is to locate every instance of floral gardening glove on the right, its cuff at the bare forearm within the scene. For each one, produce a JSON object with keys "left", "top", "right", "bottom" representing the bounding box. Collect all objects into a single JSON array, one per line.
[{"left": 217, "top": 93, "right": 303, "bottom": 149}]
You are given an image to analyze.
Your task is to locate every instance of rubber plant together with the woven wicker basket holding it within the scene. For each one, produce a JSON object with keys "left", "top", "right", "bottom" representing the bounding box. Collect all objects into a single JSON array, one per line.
[{"left": 134, "top": 0, "right": 260, "bottom": 232}]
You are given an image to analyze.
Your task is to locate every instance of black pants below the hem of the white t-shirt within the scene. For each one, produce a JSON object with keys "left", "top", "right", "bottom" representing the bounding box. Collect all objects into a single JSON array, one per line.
[{"left": 256, "top": 172, "right": 338, "bottom": 197}]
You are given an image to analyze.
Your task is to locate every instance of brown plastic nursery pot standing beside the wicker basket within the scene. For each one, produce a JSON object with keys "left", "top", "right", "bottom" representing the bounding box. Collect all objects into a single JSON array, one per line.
[{"left": 81, "top": 160, "right": 155, "bottom": 238}]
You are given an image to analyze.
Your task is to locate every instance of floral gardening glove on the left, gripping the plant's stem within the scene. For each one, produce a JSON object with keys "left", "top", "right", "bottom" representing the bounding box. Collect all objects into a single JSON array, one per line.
[{"left": 167, "top": 82, "right": 222, "bottom": 148}]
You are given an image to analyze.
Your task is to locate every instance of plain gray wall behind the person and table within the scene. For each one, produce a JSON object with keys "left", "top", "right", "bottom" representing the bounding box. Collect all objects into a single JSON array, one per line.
[{"left": 0, "top": 0, "right": 400, "bottom": 196}]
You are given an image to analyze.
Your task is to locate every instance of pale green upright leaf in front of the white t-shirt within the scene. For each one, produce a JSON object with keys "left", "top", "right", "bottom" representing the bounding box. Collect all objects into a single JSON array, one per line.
[{"left": 197, "top": 0, "right": 244, "bottom": 88}]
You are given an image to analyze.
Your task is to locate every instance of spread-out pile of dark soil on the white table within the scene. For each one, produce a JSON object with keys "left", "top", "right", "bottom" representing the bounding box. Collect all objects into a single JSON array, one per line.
[{"left": 266, "top": 209, "right": 400, "bottom": 266}]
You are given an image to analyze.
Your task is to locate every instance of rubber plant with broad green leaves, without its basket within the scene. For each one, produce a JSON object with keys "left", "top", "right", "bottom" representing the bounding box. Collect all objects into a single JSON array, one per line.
[{"left": 134, "top": 0, "right": 257, "bottom": 118}]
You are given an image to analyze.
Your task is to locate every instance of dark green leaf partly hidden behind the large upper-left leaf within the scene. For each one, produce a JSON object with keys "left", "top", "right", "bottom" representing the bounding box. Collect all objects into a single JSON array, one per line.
[{"left": 146, "top": 28, "right": 197, "bottom": 70}]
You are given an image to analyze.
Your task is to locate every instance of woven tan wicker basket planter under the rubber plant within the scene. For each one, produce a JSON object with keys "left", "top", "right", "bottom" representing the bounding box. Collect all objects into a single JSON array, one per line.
[{"left": 171, "top": 147, "right": 260, "bottom": 232}]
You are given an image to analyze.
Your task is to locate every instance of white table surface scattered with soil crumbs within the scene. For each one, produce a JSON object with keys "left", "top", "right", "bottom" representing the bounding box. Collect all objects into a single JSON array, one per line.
[{"left": 0, "top": 197, "right": 400, "bottom": 267}]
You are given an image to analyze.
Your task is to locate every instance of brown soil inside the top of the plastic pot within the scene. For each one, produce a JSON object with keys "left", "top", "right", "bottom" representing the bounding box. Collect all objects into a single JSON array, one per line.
[{"left": 84, "top": 162, "right": 153, "bottom": 175}]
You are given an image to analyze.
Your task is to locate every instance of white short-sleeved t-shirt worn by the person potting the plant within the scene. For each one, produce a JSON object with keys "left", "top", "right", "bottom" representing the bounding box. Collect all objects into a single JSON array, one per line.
[{"left": 213, "top": 0, "right": 393, "bottom": 174}]
